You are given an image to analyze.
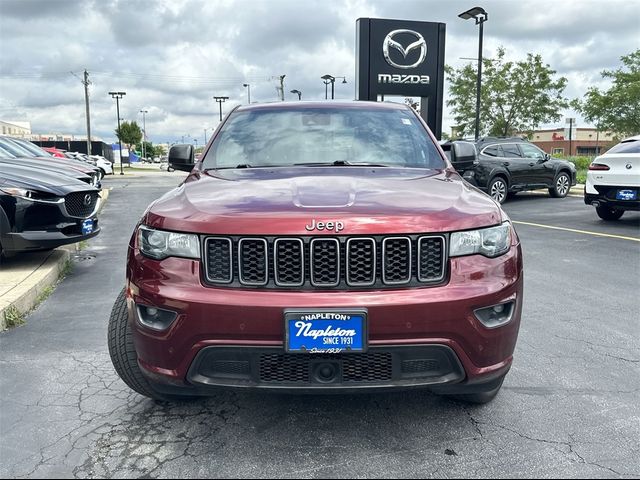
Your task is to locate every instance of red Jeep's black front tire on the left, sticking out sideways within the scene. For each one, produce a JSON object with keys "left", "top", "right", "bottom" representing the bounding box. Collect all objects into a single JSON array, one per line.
[{"left": 107, "top": 288, "right": 191, "bottom": 402}]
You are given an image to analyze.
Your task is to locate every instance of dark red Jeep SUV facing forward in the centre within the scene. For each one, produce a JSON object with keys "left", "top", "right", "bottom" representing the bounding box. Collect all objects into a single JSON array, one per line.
[{"left": 108, "top": 102, "right": 523, "bottom": 402}]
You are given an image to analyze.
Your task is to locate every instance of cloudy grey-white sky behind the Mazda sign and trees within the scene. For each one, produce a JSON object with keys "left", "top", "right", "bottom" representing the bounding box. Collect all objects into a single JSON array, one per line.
[{"left": 0, "top": 0, "right": 640, "bottom": 144}]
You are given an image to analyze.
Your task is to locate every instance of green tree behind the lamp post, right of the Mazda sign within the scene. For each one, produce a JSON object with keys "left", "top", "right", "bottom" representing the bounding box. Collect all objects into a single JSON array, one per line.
[{"left": 445, "top": 48, "right": 569, "bottom": 136}]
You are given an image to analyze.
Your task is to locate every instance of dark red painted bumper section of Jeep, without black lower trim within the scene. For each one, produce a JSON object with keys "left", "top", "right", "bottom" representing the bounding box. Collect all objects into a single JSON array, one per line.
[{"left": 127, "top": 244, "right": 523, "bottom": 379}]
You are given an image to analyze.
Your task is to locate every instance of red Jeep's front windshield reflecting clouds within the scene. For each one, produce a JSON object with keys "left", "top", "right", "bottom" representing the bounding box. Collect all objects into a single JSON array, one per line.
[{"left": 203, "top": 106, "right": 446, "bottom": 169}]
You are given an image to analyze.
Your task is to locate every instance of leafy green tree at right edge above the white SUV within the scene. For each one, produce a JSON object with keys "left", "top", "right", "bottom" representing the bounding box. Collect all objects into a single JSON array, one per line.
[{"left": 571, "top": 49, "right": 640, "bottom": 137}]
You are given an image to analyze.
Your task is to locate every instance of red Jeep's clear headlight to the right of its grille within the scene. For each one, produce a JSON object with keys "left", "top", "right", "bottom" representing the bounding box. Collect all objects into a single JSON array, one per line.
[{"left": 449, "top": 222, "right": 511, "bottom": 258}]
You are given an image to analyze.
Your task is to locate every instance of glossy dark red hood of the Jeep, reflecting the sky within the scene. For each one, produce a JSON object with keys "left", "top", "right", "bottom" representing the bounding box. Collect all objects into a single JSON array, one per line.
[{"left": 143, "top": 167, "right": 503, "bottom": 235}]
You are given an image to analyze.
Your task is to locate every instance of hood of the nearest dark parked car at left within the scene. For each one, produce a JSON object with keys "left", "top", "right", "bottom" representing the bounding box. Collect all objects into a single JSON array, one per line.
[{"left": 0, "top": 163, "right": 98, "bottom": 196}]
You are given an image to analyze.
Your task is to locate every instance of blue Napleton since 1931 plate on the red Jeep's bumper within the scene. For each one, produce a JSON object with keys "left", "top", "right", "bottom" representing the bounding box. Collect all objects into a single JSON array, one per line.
[{"left": 284, "top": 309, "right": 367, "bottom": 353}]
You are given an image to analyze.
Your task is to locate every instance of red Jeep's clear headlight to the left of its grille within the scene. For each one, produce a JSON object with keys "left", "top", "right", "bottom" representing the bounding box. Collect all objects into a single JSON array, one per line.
[{"left": 138, "top": 226, "right": 200, "bottom": 260}]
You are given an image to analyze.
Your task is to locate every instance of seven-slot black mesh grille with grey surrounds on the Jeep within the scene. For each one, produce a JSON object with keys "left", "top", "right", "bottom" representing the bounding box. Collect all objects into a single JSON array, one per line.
[{"left": 202, "top": 235, "right": 447, "bottom": 290}]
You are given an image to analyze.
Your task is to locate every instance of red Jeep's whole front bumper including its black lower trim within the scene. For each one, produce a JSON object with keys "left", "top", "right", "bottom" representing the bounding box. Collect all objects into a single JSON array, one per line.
[{"left": 127, "top": 244, "right": 523, "bottom": 393}]
